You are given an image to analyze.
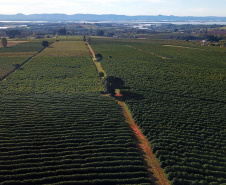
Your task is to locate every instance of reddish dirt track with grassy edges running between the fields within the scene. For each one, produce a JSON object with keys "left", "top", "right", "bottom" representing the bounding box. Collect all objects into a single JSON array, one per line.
[{"left": 86, "top": 42, "right": 170, "bottom": 185}]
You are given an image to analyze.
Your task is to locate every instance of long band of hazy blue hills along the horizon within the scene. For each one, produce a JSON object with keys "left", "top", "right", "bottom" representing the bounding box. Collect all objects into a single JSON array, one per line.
[{"left": 0, "top": 14, "right": 226, "bottom": 21}]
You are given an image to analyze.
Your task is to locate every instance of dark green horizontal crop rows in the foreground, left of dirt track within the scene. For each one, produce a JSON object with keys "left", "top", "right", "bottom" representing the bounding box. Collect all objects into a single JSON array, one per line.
[{"left": 0, "top": 93, "right": 150, "bottom": 184}]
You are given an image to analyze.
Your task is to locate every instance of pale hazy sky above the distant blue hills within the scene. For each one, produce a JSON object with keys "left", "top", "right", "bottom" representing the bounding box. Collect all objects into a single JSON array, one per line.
[{"left": 0, "top": 0, "right": 226, "bottom": 17}]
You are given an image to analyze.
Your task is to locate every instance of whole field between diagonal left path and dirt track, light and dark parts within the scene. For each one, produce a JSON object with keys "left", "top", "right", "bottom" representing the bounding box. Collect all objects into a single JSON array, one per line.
[{"left": 0, "top": 40, "right": 151, "bottom": 185}]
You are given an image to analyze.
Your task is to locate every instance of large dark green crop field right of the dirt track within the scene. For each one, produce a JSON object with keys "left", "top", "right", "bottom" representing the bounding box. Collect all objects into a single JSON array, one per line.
[{"left": 91, "top": 38, "right": 226, "bottom": 185}]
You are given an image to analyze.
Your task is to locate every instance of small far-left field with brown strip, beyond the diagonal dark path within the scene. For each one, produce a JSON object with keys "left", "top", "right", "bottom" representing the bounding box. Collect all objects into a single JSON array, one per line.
[{"left": 0, "top": 41, "right": 43, "bottom": 80}]
